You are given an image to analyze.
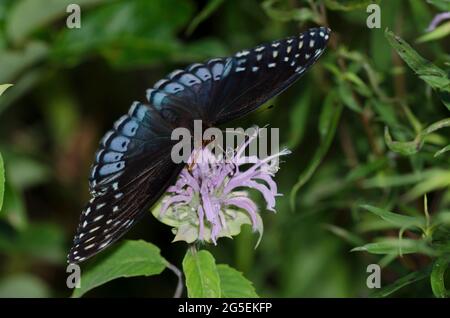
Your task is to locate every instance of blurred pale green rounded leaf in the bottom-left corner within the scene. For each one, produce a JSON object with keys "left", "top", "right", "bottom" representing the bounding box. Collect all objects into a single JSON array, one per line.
[{"left": 0, "top": 274, "right": 51, "bottom": 298}]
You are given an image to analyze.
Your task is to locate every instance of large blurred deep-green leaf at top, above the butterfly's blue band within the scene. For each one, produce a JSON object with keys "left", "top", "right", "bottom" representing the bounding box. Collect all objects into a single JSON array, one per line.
[{"left": 52, "top": 0, "right": 193, "bottom": 67}]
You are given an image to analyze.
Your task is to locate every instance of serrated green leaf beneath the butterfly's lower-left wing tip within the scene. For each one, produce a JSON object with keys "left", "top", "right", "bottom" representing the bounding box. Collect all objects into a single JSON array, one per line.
[{"left": 72, "top": 240, "right": 167, "bottom": 297}]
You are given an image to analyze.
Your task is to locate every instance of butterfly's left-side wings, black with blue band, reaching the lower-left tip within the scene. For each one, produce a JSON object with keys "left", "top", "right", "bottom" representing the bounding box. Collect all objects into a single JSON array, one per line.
[{"left": 68, "top": 103, "right": 183, "bottom": 263}]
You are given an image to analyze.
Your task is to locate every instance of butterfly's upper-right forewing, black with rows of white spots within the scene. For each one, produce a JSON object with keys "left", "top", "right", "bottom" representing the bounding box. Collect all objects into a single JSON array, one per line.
[{"left": 208, "top": 27, "right": 330, "bottom": 125}]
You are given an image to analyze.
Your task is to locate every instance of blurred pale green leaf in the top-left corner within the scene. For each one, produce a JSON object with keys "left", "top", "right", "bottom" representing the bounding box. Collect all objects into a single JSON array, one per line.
[{"left": 6, "top": 0, "right": 105, "bottom": 43}]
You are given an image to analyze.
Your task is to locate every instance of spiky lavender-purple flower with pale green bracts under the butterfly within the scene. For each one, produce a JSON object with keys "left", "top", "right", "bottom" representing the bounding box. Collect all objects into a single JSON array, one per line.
[{"left": 158, "top": 130, "right": 290, "bottom": 244}]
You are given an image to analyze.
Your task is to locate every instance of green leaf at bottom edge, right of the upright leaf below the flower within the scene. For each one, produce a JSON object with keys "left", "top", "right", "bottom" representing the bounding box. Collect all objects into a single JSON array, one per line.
[{"left": 217, "top": 264, "right": 258, "bottom": 298}]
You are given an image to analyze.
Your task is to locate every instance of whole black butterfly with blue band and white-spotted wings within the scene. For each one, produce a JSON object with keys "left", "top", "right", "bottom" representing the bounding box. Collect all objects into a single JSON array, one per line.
[{"left": 68, "top": 27, "right": 330, "bottom": 263}]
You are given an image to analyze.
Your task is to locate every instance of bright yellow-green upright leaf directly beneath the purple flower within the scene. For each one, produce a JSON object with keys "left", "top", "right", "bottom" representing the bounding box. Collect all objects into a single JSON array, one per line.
[{"left": 183, "top": 249, "right": 221, "bottom": 298}]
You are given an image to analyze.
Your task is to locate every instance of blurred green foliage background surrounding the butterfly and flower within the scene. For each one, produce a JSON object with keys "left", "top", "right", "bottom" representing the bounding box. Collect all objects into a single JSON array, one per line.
[{"left": 0, "top": 0, "right": 450, "bottom": 297}]
